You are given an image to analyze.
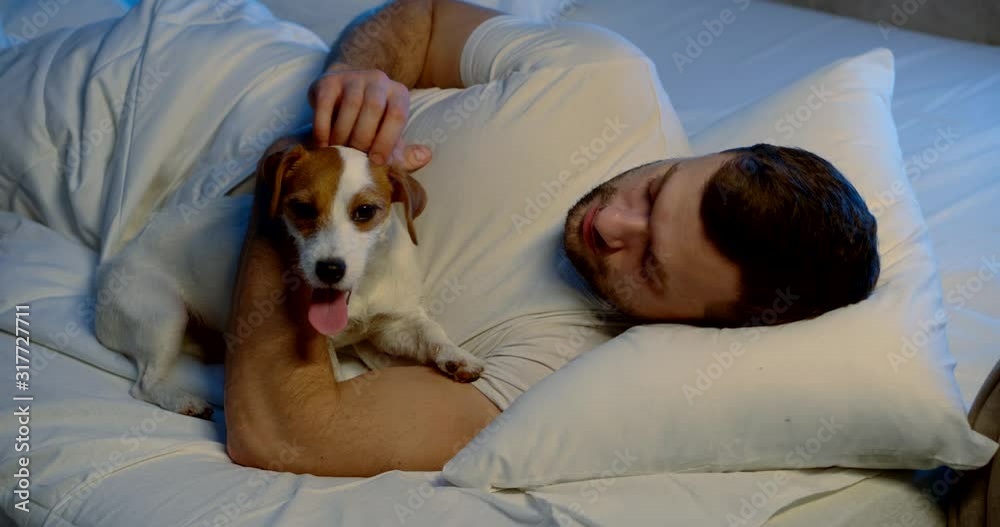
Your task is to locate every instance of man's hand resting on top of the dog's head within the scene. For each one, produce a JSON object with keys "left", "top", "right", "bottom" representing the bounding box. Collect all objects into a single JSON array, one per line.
[{"left": 309, "top": 64, "right": 431, "bottom": 172}]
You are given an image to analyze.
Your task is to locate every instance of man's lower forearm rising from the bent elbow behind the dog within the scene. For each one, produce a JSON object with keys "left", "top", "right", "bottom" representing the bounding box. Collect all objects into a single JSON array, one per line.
[{"left": 225, "top": 225, "right": 338, "bottom": 472}]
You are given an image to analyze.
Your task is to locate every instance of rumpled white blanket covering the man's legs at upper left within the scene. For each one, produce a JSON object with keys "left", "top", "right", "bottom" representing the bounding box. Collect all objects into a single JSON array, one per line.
[{"left": 0, "top": 2, "right": 327, "bottom": 258}]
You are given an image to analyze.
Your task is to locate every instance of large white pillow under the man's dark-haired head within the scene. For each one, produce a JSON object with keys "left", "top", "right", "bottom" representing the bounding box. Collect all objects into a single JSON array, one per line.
[{"left": 444, "top": 49, "right": 997, "bottom": 488}]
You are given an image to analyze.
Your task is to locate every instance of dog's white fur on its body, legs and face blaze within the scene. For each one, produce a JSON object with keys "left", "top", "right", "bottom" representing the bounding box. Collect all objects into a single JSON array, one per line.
[{"left": 95, "top": 147, "right": 483, "bottom": 417}]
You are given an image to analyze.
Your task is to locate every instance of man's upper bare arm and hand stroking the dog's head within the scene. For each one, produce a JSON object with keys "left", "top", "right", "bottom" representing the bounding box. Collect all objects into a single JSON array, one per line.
[{"left": 309, "top": 0, "right": 502, "bottom": 165}]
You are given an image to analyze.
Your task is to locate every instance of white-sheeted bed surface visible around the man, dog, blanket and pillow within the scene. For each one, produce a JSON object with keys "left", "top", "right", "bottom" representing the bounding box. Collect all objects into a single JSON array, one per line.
[{"left": 0, "top": 0, "right": 1000, "bottom": 526}]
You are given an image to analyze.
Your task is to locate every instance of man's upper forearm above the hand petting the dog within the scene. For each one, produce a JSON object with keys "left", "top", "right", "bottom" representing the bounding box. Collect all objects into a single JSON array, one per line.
[{"left": 327, "top": 0, "right": 433, "bottom": 88}]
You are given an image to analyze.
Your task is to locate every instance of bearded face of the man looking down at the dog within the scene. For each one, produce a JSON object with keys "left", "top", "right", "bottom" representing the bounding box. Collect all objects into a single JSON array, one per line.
[{"left": 564, "top": 154, "right": 740, "bottom": 321}]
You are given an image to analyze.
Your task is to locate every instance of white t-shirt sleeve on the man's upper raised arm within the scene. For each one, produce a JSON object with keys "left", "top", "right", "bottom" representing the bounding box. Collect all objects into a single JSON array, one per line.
[{"left": 460, "top": 15, "right": 649, "bottom": 86}]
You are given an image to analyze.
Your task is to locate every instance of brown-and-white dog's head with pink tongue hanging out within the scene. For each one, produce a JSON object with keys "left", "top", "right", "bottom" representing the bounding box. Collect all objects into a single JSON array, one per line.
[{"left": 257, "top": 144, "right": 427, "bottom": 335}]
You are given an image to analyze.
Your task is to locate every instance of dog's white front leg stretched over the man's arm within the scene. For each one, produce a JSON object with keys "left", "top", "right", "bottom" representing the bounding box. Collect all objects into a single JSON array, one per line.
[{"left": 370, "top": 309, "right": 485, "bottom": 382}]
